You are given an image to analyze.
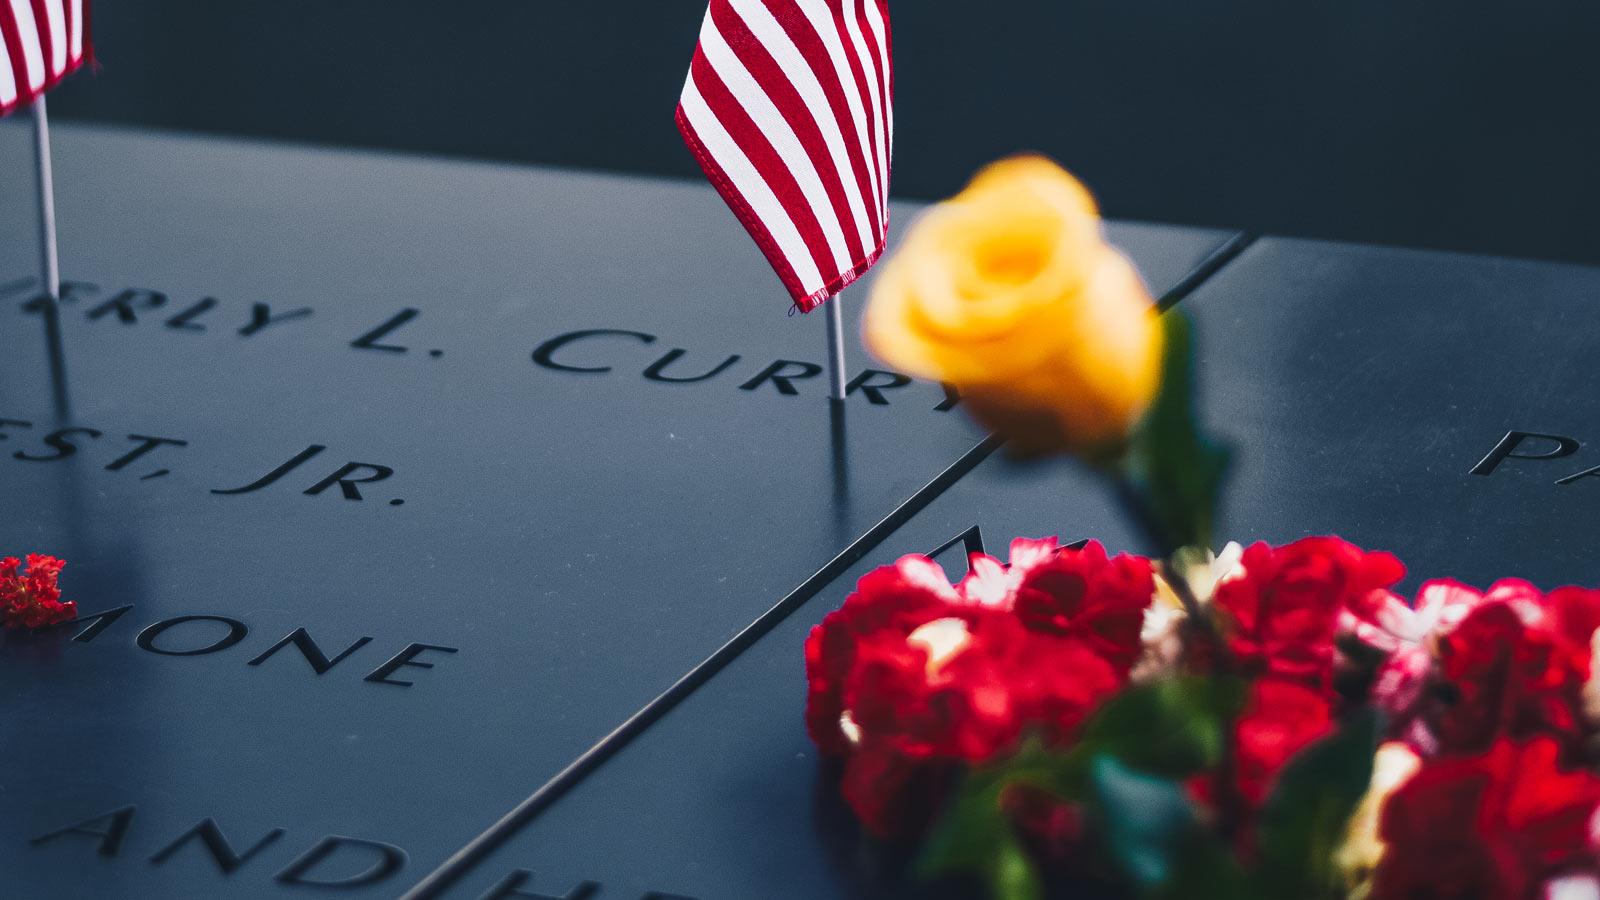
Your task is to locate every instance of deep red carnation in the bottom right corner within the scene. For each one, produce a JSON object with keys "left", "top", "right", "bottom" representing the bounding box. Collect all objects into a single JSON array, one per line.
[{"left": 1371, "top": 738, "right": 1600, "bottom": 900}]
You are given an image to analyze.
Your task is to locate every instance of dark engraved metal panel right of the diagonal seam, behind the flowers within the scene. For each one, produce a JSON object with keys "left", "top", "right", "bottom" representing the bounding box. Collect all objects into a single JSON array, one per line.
[{"left": 428, "top": 239, "right": 1600, "bottom": 900}]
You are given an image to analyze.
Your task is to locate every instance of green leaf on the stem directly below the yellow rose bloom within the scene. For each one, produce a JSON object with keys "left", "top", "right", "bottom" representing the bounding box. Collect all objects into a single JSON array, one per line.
[{"left": 1120, "top": 309, "right": 1230, "bottom": 554}]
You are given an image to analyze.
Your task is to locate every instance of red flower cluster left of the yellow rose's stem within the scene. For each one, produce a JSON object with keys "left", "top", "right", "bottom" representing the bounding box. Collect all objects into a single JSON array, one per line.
[{"left": 805, "top": 538, "right": 1155, "bottom": 834}]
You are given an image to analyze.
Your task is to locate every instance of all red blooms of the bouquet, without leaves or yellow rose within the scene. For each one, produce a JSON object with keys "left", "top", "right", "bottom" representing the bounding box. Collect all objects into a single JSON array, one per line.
[{"left": 806, "top": 538, "right": 1600, "bottom": 900}]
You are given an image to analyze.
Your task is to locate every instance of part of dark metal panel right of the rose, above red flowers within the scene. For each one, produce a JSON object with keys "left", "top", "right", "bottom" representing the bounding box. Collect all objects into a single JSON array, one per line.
[{"left": 1203, "top": 239, "right": 1600, "bottom": 588}]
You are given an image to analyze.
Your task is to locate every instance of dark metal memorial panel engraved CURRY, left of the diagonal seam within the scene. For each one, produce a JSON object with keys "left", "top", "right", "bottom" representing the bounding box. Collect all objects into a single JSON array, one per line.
[{"left": 0, "top": 125, "right": 1226, "bottom": 898}]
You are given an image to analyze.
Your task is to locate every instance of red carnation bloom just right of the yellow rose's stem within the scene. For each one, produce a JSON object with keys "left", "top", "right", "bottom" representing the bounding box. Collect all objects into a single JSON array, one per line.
[{"left": 1213, "top": 538, "right": 1405, "bottom": 689}]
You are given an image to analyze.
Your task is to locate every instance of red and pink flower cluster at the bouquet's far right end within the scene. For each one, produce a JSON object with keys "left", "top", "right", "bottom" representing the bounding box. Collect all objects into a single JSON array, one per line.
[{"left": 1354, "top": 580, "right": 1600, "bottom": 900}]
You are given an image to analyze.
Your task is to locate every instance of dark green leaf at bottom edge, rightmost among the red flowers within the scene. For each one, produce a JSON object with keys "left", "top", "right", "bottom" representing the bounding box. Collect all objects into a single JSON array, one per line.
[{"left": 1259, "top": 708, "right": 1381, "bottom": 900}]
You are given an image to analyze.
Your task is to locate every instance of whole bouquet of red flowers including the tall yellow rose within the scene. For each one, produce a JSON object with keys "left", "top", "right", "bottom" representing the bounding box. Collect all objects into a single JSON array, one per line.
[{"left": 805, "top": 159, "right": 1600, "bottom": 900}]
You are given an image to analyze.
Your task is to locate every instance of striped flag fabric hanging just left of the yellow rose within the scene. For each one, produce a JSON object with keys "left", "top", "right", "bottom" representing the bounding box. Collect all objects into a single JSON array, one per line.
[{"left": 677, "top": 0, "right": 894, "bottom": 312}]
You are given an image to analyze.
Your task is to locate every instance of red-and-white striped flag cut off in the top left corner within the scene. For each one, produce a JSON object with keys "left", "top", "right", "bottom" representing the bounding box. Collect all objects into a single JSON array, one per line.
[{"left": 0, "top": 0, "right": 91, "bottom": 115}]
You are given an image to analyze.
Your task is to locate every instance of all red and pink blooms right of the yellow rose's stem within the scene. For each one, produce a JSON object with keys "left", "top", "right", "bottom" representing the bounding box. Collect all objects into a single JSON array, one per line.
[{"left": 1213, "top": 538, "right": 1600, "bottom": 900}]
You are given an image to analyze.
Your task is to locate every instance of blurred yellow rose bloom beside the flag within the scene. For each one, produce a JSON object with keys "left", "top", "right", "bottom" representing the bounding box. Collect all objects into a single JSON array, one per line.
[{"left": 864, "top": 155, "right": 1162, "bottom": 455}]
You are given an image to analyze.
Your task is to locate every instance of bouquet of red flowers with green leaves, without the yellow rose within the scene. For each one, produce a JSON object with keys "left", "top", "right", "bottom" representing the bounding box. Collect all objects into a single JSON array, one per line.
[{"left": 806, "top": 538, "right": 1600, "bottom": 900}]
